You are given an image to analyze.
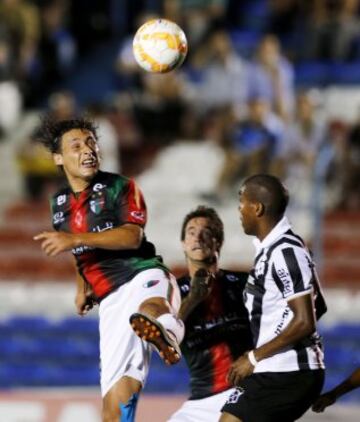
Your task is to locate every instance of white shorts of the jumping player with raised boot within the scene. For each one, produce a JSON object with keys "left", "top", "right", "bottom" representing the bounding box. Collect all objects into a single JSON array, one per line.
[{"left": 99, "top": 268, "right": 181, "bottom": 397}]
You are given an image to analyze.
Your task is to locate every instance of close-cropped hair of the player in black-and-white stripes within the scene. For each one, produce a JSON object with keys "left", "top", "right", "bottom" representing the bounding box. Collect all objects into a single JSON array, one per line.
[{"left": 243, "top": 174, "right": 289, "bottom": 218}]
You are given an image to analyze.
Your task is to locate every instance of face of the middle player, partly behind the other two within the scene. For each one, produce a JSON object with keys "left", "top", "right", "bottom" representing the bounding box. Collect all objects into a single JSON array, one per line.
[{"left": 182, "top": 217, "right": 218, "bottom": 261}]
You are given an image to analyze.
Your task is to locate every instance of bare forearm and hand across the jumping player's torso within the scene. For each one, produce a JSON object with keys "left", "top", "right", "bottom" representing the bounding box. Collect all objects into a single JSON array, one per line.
[{"left": 34, "top": 224, "right": 143, "bottom": 256}]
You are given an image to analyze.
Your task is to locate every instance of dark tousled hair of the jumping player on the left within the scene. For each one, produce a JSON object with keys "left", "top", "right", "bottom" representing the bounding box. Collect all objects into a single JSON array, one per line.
[{"left": 33, "top": 117, "right": 98, "bottom": 154}]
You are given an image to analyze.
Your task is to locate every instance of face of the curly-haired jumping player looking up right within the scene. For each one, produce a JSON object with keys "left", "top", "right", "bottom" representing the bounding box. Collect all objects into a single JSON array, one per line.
[{"left": 54, "top": 129, "right": 100, "bottom": 185}]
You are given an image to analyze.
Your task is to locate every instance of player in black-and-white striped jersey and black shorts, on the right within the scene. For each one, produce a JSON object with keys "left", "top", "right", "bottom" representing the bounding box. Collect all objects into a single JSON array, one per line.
[{"left": 220, "top": 175, "right": 326, "bottom": 422}]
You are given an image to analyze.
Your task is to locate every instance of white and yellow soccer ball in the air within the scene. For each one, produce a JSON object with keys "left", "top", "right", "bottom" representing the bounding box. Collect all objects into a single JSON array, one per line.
[{"left": 133, "top": 19, "right": 188, "bottom": 73}]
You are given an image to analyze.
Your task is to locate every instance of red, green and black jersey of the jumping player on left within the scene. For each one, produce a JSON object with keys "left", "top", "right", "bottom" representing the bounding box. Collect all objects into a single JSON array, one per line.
[{"left": 51, "top": 171, "right": 168, "bottom": 300}]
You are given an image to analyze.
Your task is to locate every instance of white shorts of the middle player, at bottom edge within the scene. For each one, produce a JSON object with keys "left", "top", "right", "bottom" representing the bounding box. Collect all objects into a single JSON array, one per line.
[{"left": 167, "top": 388, "right": 235, "bottom": 422}]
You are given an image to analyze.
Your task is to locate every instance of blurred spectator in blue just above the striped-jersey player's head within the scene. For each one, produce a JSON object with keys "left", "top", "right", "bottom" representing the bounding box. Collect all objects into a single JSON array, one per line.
[{"left": 203, "top": 98, "right": 283, "bottom": 201}]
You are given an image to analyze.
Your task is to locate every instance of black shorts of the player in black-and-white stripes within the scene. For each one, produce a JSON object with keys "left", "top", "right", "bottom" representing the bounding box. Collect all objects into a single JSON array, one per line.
[{"left": 222, "top": 369, "right": 324, "bottom": 422}]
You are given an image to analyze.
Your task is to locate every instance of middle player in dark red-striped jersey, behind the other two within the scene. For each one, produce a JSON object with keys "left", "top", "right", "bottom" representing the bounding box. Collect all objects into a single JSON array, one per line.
[{"left": 169, "top": 206, "right": 252, "bottom": 422}]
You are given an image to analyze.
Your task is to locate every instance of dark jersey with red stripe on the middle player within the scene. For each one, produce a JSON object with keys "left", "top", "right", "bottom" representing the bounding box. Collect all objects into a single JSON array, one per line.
[{"left": 178, "top": 270, "right": 252, "bottom": 399}]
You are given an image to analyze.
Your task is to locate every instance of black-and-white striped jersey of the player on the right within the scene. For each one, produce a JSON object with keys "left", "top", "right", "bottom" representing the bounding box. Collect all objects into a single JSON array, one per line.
[{"left": 245, "top": 217, "right": 324, "bottom": 372}]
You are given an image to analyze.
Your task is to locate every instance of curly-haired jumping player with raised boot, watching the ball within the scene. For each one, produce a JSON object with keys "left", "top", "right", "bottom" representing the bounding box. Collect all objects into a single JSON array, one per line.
[{"left": 34, "top": 119, "right": 184, "bottom": 422}]
